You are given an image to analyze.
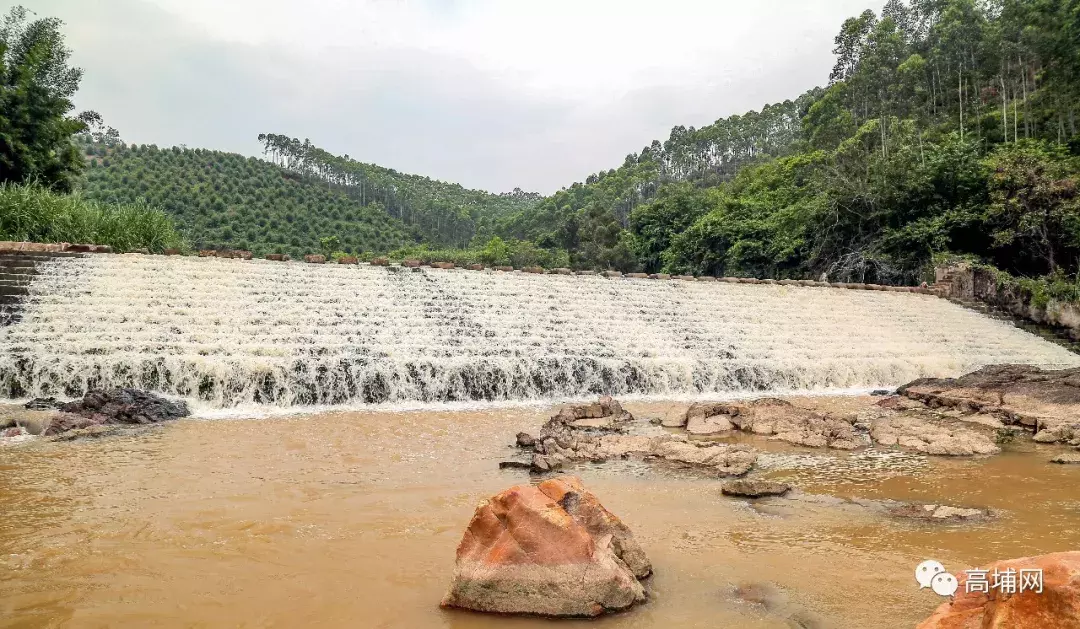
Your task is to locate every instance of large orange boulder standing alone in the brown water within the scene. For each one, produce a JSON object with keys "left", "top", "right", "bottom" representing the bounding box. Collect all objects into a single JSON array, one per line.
[{"left": 442, "top": 477, "right": 652, "bottom": 616}]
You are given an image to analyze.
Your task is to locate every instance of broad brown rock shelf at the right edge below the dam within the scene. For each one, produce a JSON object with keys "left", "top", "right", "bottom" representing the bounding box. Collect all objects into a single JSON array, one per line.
[{"left": 899, "top": 365, "right": 1080, "bottom": 443}]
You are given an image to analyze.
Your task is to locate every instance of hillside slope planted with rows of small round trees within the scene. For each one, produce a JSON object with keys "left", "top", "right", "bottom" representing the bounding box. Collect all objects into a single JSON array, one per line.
[{"left": 78, "top": 144, "right": 418, "bottom": 255}]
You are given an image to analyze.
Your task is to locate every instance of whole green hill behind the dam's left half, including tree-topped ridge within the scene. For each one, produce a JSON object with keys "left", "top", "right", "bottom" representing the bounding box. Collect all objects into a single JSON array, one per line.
[{"left": 81, "top": 134, "right": 540, "bottom": 256}]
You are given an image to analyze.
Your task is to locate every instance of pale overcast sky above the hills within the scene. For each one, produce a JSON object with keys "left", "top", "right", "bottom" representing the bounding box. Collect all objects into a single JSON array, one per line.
[{"left": 29, "top": 0, "right": 881, "bottom": 192}]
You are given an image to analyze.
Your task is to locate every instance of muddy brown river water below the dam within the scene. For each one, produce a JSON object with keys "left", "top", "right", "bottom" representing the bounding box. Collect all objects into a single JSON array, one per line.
[{"left": 0, "top": 400, "right": 1080, "bottom": 629}]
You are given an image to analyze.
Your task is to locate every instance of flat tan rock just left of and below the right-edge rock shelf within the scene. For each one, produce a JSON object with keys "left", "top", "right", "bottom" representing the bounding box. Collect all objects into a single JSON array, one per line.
[{"left": 870, "top": 410, "right": 1001, "bottom": 456}]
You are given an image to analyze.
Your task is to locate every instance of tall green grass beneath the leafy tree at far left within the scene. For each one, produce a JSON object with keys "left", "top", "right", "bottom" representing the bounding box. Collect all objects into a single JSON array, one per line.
[{"left": 0, "top": 184, "right": 186, "bottom": 253}]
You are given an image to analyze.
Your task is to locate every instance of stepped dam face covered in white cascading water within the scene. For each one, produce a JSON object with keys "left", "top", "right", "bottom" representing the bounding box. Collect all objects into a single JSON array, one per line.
[{"left": 0, "top": 254, "right": 1080, "bottom": 407}]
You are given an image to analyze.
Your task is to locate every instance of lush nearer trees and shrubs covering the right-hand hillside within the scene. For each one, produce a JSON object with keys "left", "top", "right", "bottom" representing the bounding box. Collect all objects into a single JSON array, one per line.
[{"left": 612, "top": 0, "right": 1080, "bottom": 282}]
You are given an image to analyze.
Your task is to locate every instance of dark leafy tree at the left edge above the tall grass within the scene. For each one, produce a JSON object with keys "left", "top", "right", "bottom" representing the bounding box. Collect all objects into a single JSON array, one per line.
[{"left": 0, "top": 6, "right": 99, "bottom": 191}]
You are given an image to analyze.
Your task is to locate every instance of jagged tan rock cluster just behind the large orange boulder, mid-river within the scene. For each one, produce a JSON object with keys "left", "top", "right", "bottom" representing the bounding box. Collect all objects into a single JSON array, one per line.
[{"left": 527, "top": 397, "right": 757, "bottom": 476}]
